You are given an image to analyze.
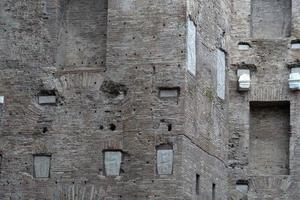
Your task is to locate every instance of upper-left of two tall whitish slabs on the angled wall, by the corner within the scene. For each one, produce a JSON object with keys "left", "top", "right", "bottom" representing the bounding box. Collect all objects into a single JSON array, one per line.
[{"left": 187, "top": 19, "right": 196, "bottom": 75}]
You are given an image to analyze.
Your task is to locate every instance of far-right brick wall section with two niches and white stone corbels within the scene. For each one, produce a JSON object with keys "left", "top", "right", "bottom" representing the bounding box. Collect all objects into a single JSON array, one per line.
[{"left": 229, "top": 0, "right": 300, "bottom": 199}]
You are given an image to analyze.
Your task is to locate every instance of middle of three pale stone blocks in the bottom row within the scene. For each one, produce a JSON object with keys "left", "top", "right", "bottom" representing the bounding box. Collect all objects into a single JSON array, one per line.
[{"left": 104, "top": 150, "right": 122, "bottom": 176}]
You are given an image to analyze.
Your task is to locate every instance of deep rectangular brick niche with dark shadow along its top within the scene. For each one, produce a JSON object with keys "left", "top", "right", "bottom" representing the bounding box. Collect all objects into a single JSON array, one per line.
[{"left": 249, "top": 101, "right": 290, "bottom": 176}]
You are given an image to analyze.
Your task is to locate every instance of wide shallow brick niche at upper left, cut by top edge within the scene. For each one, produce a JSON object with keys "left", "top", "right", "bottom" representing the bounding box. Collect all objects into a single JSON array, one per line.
[{"left": 57, "top": 0, "right": 108, "bottom": 69}]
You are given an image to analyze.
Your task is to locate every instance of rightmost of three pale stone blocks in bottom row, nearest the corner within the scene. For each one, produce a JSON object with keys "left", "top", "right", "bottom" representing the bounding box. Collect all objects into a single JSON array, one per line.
[{"left": 157, "top": 149, "right": 173, "bottom": 175}]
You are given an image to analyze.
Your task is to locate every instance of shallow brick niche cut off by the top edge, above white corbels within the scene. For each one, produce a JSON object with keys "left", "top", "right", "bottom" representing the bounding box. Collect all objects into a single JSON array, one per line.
[{"left": 251, "top": 0, "right": 292, "bottom": 39}]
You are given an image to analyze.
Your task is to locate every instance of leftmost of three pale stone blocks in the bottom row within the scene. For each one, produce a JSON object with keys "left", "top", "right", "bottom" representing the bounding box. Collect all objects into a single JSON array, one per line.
[{"left": 33, "top": 155, "right": 51, "bottom": 178}]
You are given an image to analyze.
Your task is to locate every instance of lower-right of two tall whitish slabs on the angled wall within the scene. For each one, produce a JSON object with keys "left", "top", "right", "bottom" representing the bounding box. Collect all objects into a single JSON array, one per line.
[{"left": 217, "top": 49, "right": 226, "bottom": 100}]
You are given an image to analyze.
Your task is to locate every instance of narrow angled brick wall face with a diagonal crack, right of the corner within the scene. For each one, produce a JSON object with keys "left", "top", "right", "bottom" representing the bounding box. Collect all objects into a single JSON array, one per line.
[{"left": 183, "top": 0, "right": 231, "bottom": 200}]
